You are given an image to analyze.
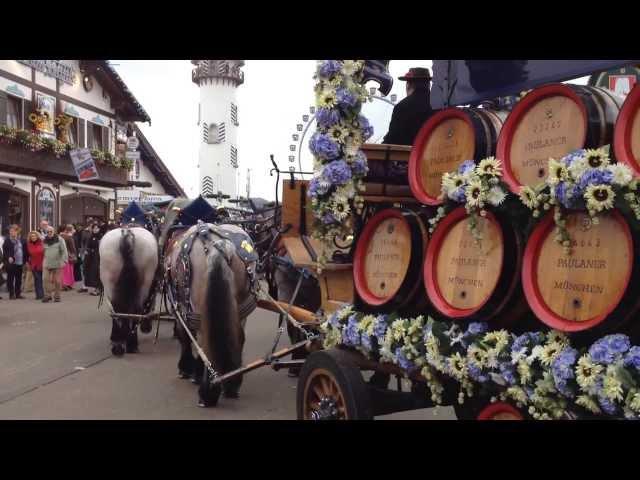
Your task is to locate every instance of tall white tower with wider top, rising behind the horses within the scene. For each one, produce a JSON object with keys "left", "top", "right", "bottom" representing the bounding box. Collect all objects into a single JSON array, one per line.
[{"left": 191, "top": 60, "right": 244, "bottom": 203}]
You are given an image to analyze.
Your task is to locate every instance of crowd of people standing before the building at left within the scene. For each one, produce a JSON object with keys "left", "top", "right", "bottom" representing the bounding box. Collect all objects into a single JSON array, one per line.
[{"left": 0, "top": 219, "right": 115, "bottom": 303}]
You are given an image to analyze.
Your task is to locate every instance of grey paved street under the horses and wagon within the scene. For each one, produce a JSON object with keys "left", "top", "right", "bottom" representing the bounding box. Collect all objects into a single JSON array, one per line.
[{"left": 0, "top": 284, "right": 455, "bottom": 420}]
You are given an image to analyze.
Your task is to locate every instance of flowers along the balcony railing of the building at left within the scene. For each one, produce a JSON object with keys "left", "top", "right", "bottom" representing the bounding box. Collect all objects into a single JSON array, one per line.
[{"left": 0, "top": 125, "right": 133, "bottom": 170}]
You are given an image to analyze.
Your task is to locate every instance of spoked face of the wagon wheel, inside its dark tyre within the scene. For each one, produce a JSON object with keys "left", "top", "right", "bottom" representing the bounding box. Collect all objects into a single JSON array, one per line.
[{"left": 303, "top": 368, "right": 349, "bottom": 420}]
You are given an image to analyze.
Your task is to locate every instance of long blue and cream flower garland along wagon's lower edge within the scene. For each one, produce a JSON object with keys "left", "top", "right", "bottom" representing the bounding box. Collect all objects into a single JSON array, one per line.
[{"left": 322, "top": 305, "right": 640, "bottom": 419}]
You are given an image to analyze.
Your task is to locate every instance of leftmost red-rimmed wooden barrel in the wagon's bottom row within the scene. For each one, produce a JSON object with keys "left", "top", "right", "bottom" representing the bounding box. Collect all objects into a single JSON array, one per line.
[{"left": 353, "top": 208, "right": 428, "bottom": 311}]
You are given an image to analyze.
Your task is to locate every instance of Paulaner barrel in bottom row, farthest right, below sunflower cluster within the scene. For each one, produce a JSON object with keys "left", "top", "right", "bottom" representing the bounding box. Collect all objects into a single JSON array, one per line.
[{"left": 522, "top": 211, "right": 640, "bottom": 333}]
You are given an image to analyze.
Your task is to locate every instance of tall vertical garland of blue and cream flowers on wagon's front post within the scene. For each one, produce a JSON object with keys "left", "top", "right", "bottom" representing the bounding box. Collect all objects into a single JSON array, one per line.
[{"left": 309, "top": 60, "right": 373, "bottom": 268}]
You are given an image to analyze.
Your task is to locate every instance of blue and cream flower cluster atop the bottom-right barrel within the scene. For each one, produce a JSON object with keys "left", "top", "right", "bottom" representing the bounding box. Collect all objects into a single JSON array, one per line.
[{"left": 520, "top": 145, "right": 640, "bottom": 254}]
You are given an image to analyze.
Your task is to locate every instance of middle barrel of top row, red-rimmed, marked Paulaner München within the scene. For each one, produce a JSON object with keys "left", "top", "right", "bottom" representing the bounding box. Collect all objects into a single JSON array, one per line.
[{"left": 496, "top": 84, "right": 622, "bottom": 194}]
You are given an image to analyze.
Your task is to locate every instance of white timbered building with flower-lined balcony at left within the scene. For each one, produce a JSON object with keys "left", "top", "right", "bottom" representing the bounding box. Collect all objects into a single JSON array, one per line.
[{"left": 0, "top": 60, "right": 184, "bottom": 233}]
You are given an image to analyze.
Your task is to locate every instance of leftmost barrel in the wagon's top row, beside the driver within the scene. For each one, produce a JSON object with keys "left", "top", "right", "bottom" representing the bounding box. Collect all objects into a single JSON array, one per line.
[{"left": 408, "top": 108, "right": 506, "bottom": 205}]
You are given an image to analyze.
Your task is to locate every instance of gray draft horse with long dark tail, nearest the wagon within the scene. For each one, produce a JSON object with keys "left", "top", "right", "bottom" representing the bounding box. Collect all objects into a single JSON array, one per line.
[{"left": 159, "top": 199, "right": 256, "bottom": 407}]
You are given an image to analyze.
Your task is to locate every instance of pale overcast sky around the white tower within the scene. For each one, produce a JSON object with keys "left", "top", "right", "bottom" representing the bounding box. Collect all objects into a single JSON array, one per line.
[{"left": 112, "top": 60, "right": 431, "bottom": 198}]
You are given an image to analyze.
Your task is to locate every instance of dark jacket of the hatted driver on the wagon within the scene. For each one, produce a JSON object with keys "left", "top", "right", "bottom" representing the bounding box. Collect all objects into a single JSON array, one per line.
[{"left": 383, "top": 88, "right": 433, "bottom": 145}]
